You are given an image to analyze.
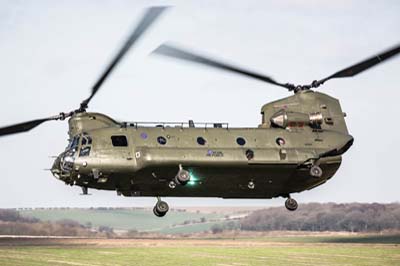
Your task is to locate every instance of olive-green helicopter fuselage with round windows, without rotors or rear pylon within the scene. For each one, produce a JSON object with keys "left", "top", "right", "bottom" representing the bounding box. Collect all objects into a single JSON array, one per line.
[{"left": 53, "top": 90, "right": 353, "bottom": 198}]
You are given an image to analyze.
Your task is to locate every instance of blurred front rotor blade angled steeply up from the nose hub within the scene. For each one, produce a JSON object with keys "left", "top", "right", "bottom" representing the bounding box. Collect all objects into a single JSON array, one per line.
[{"left": 81, "top": 7, "right": 167, "bottom": 108}]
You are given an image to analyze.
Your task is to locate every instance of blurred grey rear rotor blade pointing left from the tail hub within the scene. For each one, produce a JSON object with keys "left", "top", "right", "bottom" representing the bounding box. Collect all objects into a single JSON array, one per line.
[{"left": 153, "top": 44, "right": 291, "bottom": 89}]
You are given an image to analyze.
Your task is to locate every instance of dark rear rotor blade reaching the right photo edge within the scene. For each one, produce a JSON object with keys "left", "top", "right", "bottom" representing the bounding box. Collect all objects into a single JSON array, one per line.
[{"left": 318, "top": 45, "right": 400, "bottom": 84}]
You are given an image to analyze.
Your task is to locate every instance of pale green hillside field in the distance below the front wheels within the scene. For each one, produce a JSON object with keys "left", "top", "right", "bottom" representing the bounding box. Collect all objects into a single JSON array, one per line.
[{"left": 19, "top": 208, "right": 223, "bottom": 233}]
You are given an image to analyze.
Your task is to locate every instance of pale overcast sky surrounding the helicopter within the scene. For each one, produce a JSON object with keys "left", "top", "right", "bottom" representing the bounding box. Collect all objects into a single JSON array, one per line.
[{"left": 0, "top": 0, "right": 400, "bottom": 208}]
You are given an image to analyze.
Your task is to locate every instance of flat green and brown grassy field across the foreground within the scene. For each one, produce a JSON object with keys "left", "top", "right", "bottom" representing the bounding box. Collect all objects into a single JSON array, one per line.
[{"left": 0, "top": 236, "right": 400, "bottom": 266}]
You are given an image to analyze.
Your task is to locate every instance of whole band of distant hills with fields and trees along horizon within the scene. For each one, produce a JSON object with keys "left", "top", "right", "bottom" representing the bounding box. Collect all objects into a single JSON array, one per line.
[{"left": 0, "top": 203, "right": 400, "bottom": 237}]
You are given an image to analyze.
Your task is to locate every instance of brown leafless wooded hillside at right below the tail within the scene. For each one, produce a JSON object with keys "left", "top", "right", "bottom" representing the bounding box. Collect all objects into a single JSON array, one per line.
[{"left": 240, "top": 203, "right": 400, "bottom": 232}]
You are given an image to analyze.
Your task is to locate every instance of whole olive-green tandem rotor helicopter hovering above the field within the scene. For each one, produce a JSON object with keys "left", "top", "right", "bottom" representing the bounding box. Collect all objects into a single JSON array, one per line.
[{"left": 0, "top": 7, "right": 400, "bottom": 217}]
